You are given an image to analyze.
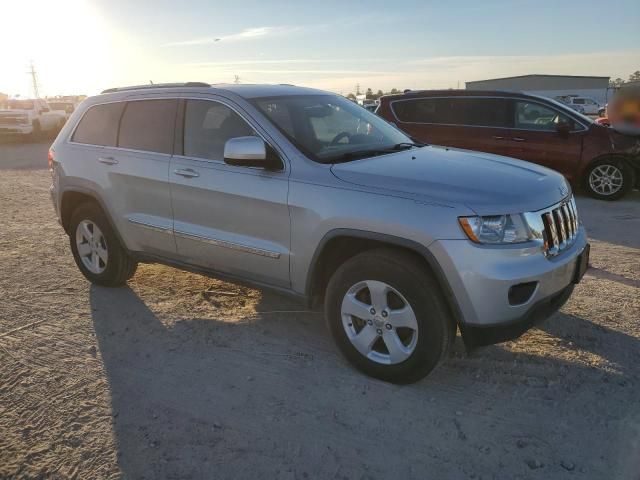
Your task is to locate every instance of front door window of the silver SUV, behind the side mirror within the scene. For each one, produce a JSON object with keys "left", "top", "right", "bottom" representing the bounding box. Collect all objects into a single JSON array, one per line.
[{"left": 184, "top": 100, "right": 255, "bottom": 160}]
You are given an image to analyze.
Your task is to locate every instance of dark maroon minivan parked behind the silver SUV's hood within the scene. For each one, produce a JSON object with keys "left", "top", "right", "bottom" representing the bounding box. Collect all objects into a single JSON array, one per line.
[{"left": 377, "top": 90, "right": 640, "bottom": 200}]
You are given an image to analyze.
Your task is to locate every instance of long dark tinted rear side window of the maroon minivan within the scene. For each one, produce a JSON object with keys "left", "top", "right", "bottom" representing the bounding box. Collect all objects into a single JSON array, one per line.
[{"left": 393, "top": 97, "right": 508, "bottom": 127}]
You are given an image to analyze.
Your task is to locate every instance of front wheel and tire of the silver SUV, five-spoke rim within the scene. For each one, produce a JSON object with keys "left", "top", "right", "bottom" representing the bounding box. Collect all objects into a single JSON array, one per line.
[{"left": 325, "top": 249, "right": 456, "bottom": 384}]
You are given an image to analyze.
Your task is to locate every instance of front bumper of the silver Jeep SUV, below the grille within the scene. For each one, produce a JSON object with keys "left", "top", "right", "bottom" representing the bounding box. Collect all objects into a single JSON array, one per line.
[{"left": 429, "top": 226, "right": 587, "bottom": 343}]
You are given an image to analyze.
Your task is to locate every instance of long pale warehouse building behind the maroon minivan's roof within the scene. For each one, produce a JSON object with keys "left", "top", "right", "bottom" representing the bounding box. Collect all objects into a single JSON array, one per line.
[{"left": 466, "top": 75, "right": 613, "bottom": 105}]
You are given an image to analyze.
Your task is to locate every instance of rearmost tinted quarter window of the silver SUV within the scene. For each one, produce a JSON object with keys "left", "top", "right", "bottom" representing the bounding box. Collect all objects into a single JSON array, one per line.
[{"left": 71, "top": 102, "right": 124, "bottom": 147}]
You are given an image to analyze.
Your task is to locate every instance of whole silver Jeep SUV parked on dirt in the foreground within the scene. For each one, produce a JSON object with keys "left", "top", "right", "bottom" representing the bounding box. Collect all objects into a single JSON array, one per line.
[{"left": 49, "top": 83, "right": 589, "bottom": 383}]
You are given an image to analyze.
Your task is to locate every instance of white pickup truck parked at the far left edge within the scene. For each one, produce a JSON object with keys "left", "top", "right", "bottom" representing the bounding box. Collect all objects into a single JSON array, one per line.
[{"left": 0, "top": 98, "right": 66, "bottom": 138}]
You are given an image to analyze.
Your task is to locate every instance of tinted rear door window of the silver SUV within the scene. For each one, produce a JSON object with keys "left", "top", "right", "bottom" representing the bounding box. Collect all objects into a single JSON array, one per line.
[{"left": 118, "top": 100, "right": 177, "bottom": 154}]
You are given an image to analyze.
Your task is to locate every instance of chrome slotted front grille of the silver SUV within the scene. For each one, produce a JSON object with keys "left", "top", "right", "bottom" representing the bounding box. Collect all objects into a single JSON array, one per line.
[{"left": 542, "top": 197, "right": 578, "bottom": 256}]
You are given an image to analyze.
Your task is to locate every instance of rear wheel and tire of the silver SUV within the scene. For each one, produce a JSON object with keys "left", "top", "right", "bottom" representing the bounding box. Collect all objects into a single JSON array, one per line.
[{"left": 69, "top": 203, "right": 138, "bottom": 287}]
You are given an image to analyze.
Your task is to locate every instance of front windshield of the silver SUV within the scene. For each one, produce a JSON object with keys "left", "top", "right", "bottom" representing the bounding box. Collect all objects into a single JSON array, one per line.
[{"left": 253, "top": 95, "right": 411, "bottom": 163}]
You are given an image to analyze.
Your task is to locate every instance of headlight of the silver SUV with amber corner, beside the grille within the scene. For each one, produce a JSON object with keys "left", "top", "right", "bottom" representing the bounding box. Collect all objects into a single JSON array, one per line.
[{"left": 458, "top": 214, "right": 533, "bottom": 244}]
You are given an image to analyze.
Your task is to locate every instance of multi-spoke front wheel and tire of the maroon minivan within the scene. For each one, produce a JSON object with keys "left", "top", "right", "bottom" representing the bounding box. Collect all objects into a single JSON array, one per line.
[{"left": 584, "top": 157, "right": 633, "bottom": 200}]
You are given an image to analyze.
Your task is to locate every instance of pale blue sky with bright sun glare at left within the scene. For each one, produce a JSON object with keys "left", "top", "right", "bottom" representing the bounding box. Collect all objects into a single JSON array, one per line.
[{"left": 0, "top": 0, "right": 640, "bottom": 97}]
